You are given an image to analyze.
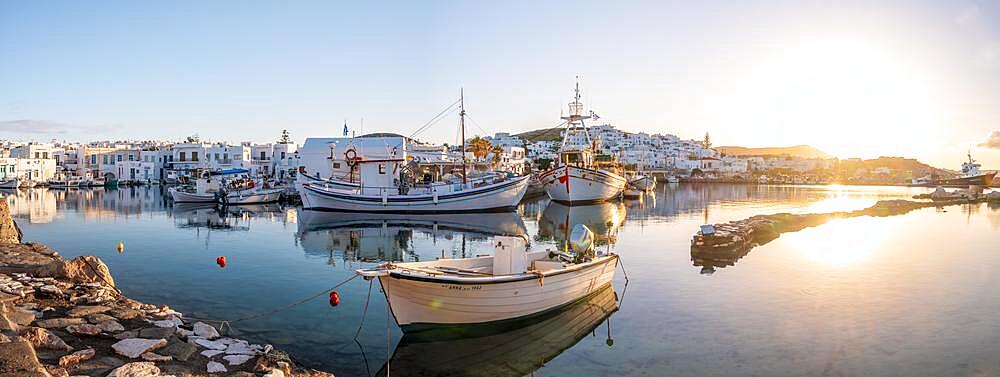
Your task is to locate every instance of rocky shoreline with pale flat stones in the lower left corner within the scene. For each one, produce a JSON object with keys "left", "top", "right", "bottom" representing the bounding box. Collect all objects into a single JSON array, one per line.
[{"left": 0, "top": 200, "right": 332, "bottom": 377}]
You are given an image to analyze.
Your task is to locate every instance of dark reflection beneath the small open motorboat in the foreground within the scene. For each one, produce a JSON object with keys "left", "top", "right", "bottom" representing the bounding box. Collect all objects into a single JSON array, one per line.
[{"left": 375, "top": 284, "right": 618, "bottom": 376}]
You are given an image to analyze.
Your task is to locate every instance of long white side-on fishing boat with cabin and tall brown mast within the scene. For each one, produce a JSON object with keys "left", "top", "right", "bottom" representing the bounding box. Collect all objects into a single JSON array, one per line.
[{"left": 299, "top": 93, "right": 530, "bottom": 213}]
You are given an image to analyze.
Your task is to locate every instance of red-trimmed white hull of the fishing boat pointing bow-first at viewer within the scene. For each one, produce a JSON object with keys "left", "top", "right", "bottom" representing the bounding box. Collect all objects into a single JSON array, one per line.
[{"left": 538, "top": 166, "right": 627, "bottom": 205}]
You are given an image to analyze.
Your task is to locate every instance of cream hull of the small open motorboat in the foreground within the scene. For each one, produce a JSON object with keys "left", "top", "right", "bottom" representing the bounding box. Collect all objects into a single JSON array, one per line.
[{"left": 379, "top": 255, "right": 618, "bottom": 333}]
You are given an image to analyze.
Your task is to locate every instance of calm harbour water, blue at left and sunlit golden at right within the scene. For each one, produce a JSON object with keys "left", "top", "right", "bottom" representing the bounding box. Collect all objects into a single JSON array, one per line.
[{"left": 0, "top": 185, "right": 1000, "bottom": 376}]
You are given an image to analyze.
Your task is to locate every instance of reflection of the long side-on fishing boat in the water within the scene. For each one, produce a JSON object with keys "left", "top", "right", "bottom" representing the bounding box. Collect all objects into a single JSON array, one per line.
[{"left": 297, "top": 210, "right": 527, "bottom": 262}]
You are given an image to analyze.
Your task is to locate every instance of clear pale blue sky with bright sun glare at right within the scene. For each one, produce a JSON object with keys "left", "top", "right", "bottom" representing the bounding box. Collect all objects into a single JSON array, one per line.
[{"left": 0, "top": 1, "right": 1000, "bottom": 168}]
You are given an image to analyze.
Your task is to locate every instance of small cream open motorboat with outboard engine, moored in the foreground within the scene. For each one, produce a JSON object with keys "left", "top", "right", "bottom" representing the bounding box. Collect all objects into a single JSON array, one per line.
[{"left": 357, "top": 225, "right": 618, "bottom": 333}]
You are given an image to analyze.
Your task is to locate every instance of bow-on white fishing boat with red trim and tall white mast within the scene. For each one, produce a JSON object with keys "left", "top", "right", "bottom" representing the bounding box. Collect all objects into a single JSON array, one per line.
[{"left": 538, "top": 78, "right": 628, "bottom": 205}]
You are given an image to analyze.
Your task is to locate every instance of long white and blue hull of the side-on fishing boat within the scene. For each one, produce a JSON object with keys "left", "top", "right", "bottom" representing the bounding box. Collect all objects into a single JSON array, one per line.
[{"left": 299, "top": 176, "right": 528, "bottom": 213}]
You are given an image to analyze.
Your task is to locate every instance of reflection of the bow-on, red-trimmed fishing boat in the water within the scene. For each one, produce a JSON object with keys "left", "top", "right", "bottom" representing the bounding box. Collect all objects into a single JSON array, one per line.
[{"left": 537, "top": 202, "right": 625, "bottom": 249}]
